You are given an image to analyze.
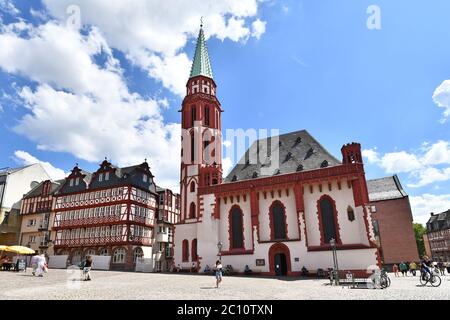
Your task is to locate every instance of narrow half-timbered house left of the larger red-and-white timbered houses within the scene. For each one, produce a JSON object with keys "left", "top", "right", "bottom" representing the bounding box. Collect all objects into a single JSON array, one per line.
[{"left": 20, "top": 180, "right": 64, "bottom": 255}]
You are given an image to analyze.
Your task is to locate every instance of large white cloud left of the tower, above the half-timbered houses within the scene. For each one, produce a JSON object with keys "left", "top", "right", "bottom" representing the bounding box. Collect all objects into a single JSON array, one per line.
[{"left": 0, "top": 23, "right": 181, "bottom": 190}]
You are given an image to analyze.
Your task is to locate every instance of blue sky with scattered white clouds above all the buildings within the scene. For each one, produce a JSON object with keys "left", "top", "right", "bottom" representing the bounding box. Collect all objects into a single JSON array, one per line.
[{"left": 0, "top": 0, "right": 450, "bottom": 222}]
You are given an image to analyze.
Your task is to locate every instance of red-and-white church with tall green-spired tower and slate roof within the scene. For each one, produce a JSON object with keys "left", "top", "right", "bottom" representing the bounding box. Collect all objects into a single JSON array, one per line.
[{"left": 174, "top": 27, "right": 381, "bottom": 276}]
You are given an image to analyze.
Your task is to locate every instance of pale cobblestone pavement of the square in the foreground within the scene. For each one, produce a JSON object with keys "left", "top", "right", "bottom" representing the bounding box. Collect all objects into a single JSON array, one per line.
[{"left": 0, "top": 270, "right": 450, "bottom": 300}]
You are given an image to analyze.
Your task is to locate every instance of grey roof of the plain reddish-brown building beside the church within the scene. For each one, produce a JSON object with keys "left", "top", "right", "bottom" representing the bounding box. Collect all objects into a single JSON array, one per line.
[{"left": 367, "top": 175, "right": 408, "bottom": 201}]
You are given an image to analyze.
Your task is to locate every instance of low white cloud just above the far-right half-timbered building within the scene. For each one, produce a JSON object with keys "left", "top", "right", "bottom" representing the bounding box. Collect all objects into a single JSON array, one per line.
[{"left": 409, "top": 194, "right": 450, "bottom": 225}]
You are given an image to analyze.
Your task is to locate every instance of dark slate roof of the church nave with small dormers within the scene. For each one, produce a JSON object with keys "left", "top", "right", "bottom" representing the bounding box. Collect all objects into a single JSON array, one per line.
[{"left": 225, "top": 130, "right": 341, "bottom": 182}]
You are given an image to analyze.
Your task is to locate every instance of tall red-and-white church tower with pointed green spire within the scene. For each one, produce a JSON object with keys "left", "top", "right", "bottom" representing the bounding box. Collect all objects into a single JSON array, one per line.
[{"left": 180, "top": 25, "right": 223, "bottom": 221}]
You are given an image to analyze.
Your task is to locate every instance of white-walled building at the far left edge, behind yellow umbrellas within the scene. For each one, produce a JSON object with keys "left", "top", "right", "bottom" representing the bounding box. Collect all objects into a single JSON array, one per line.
[{"left": 0, "top": 163, "right": 50, "bottom": 245}]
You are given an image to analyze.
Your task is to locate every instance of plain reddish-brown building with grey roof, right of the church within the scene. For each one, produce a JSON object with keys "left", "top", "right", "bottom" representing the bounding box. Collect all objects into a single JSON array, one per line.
[{"left": 367, "top": 175, "right": 419, "bottom": 267}]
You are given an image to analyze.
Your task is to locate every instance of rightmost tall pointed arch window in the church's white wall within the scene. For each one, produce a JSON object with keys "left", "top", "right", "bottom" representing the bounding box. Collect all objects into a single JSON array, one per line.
[{"left": 318, "top": 196, "right": 340, "bottom": 244}]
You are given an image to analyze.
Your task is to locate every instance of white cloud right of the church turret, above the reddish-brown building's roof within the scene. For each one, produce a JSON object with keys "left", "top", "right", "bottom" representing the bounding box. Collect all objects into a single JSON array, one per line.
[{"left": 363, "top": 140, "right": 450, "bottom": 188}]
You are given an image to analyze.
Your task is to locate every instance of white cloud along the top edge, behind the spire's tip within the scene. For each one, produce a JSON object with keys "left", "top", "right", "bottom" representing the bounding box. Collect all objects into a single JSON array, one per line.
[{"left": 40, "top": 0, "right": 265, "bottom": 96}]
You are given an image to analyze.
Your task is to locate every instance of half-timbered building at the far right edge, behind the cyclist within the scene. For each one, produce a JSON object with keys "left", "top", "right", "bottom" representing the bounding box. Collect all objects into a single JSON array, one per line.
[{"left": 424, "top": 209, "right": 450, "bottom": 262}]
